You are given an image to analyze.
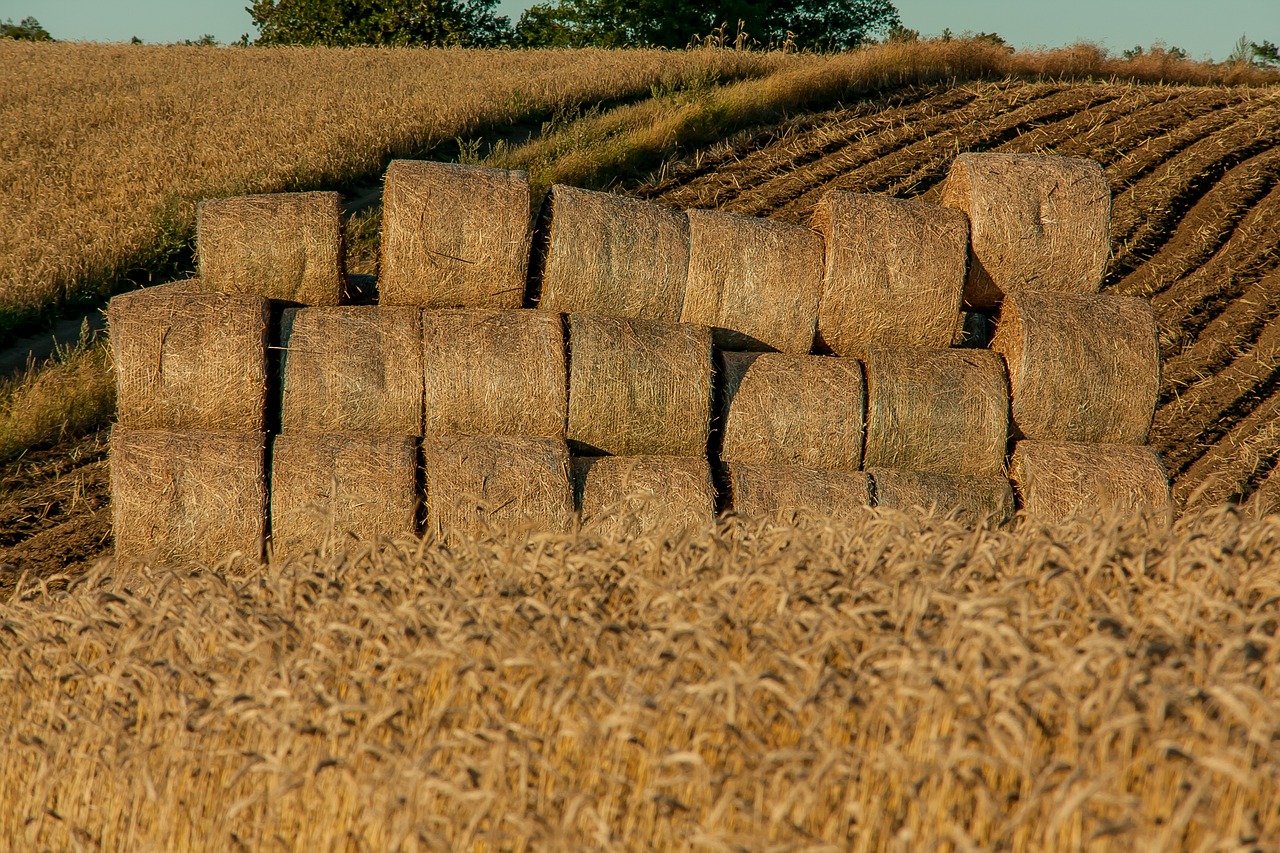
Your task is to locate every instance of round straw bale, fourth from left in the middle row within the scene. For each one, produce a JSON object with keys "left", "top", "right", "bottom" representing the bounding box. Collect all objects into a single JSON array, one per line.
[{"left": 568, "top": 314, "right": 712, "bottom": 456}]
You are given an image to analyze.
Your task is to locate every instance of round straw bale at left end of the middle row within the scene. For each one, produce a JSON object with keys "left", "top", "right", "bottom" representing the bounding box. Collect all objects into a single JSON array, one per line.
[{"left": 106, "top": 282, "right": 270, "bottom": 432}]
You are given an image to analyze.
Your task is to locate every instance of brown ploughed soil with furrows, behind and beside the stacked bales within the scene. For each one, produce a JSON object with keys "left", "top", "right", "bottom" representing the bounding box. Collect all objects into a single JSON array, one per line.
[{"left": 0, "top": 81, "right": 1280, "bottom": 585}]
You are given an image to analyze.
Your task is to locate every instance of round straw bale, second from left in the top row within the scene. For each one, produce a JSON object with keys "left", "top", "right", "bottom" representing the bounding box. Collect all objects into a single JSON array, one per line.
[{"left": 380, "top": 160, "right": 532, "bottom": 309}]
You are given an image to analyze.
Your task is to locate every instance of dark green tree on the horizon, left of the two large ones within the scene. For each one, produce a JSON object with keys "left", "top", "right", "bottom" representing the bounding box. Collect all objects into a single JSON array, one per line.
[{"left": 246, "top": 0, "right": 511, "bottom": 46}]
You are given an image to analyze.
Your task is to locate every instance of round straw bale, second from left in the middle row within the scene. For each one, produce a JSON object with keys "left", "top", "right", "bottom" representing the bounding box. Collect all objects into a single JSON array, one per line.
[{"left": 280, "top": 306, "right": 422, "bottom": 435}]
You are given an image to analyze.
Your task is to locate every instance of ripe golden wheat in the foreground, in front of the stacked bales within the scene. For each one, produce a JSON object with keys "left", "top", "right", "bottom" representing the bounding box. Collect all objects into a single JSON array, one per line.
[{"left": 0, "top": 511, "right": 1280, "bottom": 850}]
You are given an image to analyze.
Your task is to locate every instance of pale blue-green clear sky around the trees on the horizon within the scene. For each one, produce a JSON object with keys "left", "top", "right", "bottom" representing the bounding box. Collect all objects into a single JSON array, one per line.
[{"left": 0, "top": 0, "right": 1280, "bottom": 59}]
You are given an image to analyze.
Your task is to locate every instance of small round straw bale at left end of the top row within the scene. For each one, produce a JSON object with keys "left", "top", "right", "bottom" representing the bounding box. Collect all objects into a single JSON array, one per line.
[{"left": 196, "top": 192, "right": 346, "bottom": 305}]
